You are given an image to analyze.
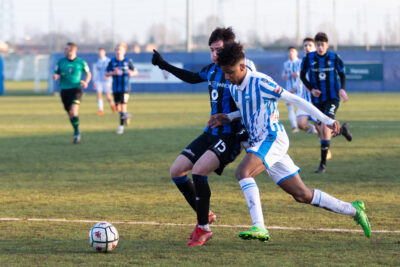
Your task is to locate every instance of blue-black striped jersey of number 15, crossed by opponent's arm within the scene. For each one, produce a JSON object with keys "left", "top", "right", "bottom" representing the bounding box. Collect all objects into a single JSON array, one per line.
[{"left": 198, "top": 63, "right": 240, "bottom": 135}]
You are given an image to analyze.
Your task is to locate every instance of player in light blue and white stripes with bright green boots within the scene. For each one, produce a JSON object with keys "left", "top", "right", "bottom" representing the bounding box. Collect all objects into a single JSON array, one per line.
[{"left": 209, "top": 43, "right": 371, "bottom": 241}]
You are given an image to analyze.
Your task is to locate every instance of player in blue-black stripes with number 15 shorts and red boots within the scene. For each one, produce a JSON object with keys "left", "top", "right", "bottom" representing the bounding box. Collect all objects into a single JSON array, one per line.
[{"left": 152, "top": 28, "right": 255, "bottom": 246}]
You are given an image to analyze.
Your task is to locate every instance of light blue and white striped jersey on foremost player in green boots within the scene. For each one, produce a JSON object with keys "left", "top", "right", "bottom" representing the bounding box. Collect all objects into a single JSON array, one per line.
[{"left": 229, "top": 68, "right": 285, "bottom": 146}]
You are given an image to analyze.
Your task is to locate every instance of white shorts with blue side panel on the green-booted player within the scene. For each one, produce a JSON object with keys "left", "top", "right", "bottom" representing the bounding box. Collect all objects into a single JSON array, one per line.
[{"left": 247, "top": 132, "right": 300, "bottom": 185}]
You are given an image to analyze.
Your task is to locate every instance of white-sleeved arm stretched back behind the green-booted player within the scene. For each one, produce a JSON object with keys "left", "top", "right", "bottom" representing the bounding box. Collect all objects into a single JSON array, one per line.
[{"left": 281, "top": 90, "right": 340, "bottom": 134}]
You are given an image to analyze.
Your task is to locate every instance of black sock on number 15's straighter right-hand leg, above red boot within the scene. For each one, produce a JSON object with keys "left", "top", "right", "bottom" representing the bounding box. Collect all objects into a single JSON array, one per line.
[{"left": 192, "top": 174, "right": 211, "bottom": 225}]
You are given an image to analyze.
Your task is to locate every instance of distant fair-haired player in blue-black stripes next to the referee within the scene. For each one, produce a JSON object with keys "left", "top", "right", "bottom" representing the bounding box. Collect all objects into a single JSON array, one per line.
[{"left": 106, "top": 43, "right": 138, "bottom": 134}]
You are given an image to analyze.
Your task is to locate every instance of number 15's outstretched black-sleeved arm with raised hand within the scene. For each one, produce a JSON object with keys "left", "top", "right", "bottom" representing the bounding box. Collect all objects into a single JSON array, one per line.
[{"left": 151, "top": 49, "right": 205, "bottom": 84}]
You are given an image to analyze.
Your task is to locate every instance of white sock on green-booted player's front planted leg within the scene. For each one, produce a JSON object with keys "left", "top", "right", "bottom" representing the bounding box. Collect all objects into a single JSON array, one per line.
[{"left": 239, "top": 178, "right": 265, "bottom": 229}]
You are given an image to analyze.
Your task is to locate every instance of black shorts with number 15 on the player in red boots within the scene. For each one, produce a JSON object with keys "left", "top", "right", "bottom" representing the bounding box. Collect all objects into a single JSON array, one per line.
[{"left": 181, "top": 133, "right": 241, "bottom": 175}]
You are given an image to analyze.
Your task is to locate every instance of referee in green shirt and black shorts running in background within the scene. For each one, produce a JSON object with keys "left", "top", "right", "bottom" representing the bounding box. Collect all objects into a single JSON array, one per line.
[{"left": 53, "top": 42, "right": 92, "bottom": 144}]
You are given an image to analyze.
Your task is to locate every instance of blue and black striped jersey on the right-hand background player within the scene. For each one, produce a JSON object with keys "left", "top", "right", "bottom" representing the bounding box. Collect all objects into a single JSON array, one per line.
[{"left": 300, "top": 51, "right": 345, "bottom": 104}]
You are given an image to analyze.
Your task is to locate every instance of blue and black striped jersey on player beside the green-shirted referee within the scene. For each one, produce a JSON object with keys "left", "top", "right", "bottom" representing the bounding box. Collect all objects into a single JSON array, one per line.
[{"left": 107, "top": 58, "right": 135, "bottom": 93}]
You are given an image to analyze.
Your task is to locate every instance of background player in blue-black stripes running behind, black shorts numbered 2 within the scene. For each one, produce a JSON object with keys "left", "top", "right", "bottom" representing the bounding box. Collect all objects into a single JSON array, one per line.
[{"left": 300, "top": 32, "right": 352, "bottom": 173}]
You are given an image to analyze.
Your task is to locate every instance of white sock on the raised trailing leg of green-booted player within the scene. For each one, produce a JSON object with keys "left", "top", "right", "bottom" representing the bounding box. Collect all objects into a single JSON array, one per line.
[{"left": 310, "top": 189, "right": 356, "bottom": 216}]
